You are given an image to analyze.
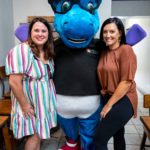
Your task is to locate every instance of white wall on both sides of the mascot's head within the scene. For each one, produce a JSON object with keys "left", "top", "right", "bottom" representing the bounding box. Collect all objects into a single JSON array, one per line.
[{"left": 13, "top": 0, "right": 111, "bottom": 43}]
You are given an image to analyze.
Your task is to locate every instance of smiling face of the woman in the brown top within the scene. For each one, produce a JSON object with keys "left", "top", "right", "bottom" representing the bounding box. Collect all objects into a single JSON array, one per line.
[{"left": 103, "top": 23, "right": 121, "bottom": 49}]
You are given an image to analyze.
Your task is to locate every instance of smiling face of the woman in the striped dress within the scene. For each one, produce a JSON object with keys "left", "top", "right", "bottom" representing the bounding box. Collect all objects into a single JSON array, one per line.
[{"left": 31, "top": 22, "right": 48, "bottom": 47}]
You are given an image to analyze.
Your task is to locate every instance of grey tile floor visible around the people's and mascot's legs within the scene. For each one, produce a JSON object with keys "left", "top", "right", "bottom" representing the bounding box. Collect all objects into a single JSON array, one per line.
[{"left": 18, "top": 93, "right": 150, "bottom": 150}]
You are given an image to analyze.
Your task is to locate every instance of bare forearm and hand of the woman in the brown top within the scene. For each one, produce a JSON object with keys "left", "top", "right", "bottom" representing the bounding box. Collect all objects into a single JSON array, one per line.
[{"left": 101, "top": 81, "right": 132, "bottom": 118}]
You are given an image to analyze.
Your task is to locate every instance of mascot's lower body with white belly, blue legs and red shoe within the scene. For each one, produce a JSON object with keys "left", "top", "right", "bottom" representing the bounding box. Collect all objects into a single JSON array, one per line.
[{"left": 56, "top": 94, "right": 102, "bottom": 150}]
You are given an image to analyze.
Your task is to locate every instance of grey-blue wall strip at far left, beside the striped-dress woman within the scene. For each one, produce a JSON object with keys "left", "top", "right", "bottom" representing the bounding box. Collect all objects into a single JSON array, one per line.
[{"left": 0, "top": 0, "right": 14, "bottom": 66}]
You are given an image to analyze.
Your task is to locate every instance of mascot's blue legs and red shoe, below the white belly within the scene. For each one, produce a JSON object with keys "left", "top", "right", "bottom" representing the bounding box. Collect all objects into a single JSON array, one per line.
[{"left": 58, "top": 105, "right": 102, "bottom": 150}]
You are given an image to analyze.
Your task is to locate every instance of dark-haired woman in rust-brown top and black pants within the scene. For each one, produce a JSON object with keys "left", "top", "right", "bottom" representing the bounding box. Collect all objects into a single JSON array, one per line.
[{"left": 94, "top": 18, "right": 137, "bottom": 150}]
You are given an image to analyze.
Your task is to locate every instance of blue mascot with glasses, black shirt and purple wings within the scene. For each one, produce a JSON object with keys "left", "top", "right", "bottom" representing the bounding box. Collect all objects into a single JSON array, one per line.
[{"left": 15, "top": 0, "right": 146, "bottom": 150}]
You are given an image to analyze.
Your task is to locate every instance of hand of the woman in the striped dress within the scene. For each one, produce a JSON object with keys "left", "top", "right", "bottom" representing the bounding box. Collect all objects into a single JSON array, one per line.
[{"left": 21, "top": 102, "right": 35, "bottom": 118}]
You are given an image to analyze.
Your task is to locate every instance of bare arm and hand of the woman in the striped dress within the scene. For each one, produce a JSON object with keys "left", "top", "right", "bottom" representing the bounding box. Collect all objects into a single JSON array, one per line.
[{"left": 9, "top": 74, "right": 34, "bottom": 118}]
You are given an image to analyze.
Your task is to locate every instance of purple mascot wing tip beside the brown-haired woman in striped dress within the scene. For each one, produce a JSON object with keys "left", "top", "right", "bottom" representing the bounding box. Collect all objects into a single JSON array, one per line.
[{"left": 15, "top": 23, "right": 29, "bottom": 42}]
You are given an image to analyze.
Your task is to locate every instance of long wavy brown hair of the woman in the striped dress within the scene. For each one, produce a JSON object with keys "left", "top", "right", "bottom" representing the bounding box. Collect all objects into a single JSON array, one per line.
[{"left": 28, "top": 17, "right": 54, "bottom": 60}]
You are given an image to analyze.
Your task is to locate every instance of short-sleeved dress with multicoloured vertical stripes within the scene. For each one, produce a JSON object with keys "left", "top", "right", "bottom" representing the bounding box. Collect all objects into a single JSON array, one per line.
[{"left": 6, "top": 43, "right": 57, "bottom": 139}]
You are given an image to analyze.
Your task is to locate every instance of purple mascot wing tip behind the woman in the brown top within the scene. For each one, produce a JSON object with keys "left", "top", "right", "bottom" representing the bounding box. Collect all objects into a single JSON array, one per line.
[{"left": 126, "top": 24, "right": 147, "bottom": 46}]
